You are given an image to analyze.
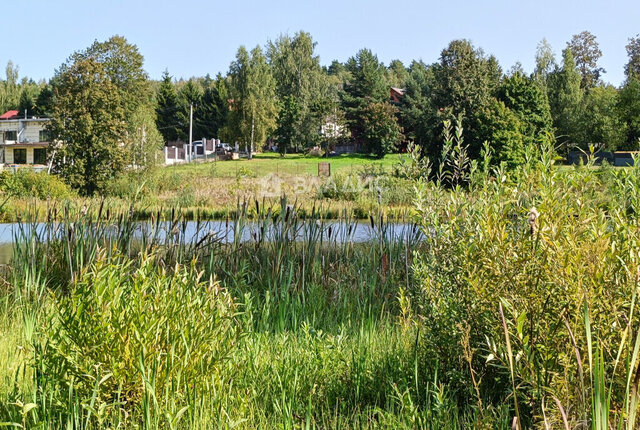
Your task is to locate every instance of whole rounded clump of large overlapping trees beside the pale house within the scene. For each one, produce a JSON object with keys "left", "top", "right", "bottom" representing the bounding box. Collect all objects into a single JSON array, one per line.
[{"left": 48, "top": 36, "right": 162, "bottom": 195}]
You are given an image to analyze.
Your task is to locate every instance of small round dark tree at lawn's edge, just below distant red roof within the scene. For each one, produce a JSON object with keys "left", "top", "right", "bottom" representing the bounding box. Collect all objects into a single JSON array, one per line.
[{"left": 361, "top": 102, "right": 404, "bottom": 158}]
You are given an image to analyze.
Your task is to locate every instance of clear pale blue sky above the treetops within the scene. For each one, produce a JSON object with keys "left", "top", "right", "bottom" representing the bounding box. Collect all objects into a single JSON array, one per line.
[{"left": 0, "top": 0, "right": 640, "bottom": 85}]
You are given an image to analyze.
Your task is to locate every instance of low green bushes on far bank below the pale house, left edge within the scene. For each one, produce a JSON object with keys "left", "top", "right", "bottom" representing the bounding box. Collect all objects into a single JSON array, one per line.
[{"left": 0, "top": 168, "right": 73, "bottom": 199}]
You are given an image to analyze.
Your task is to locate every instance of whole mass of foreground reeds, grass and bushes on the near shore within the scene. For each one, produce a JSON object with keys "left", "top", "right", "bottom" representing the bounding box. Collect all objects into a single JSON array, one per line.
[{"left": 0, "top": 139, "right": 640, "bottom": 429}]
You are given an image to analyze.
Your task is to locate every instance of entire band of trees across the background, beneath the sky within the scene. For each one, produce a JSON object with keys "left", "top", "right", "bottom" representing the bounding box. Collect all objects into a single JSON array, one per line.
[{"left": 0, "top": 31, "right": 640, "bottom": 194}]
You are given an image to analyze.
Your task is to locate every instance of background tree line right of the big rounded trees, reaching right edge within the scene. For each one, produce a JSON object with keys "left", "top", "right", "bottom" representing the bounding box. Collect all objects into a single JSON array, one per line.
[{"left": 156, "top": 31, "right": 640, "bottom": 164}]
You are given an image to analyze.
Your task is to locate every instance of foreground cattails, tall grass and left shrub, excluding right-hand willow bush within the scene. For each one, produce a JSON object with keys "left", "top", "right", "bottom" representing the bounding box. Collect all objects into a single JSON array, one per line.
[{"left": 0, "top": 199, "right": 450, "bottom": 428}]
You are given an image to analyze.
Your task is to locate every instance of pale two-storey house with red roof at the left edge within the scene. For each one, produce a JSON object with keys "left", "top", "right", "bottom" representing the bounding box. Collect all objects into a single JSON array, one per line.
[{"left": 0, "top": 110, "right": 50, "bottom": 169}]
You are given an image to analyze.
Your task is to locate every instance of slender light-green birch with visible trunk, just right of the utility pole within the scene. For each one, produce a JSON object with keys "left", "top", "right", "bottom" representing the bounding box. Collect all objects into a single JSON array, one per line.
[{"left": 229, "top": 46, "right": 278, "bottom": 158}]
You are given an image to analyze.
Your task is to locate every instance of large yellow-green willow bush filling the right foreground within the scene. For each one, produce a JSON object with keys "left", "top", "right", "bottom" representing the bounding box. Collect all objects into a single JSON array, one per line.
[{"left": 409, "top": 146, "right": 640, "bottom": 428}]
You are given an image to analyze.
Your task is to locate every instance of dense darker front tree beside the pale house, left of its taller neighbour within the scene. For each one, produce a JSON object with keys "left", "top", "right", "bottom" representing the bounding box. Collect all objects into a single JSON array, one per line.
[{"left": 50, "top": 57, "right": 127, "bottom": 195}]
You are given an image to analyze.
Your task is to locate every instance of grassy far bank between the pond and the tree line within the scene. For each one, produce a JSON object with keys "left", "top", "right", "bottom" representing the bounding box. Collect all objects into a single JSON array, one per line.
[{"left": 0, "top": 154, "right": 413, "bottom": 222}]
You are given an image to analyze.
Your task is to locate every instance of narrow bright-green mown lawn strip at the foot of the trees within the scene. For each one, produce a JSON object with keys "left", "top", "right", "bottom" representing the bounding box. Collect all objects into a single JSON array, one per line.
[{"left": 166, "top": 153, "right": 398, "bottom": 178}]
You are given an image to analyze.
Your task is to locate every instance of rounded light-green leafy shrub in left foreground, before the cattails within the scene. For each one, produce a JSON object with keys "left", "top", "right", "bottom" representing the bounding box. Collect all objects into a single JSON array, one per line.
[{"left": 36, "top": 255, "right": 241, "bottom": 424}]
